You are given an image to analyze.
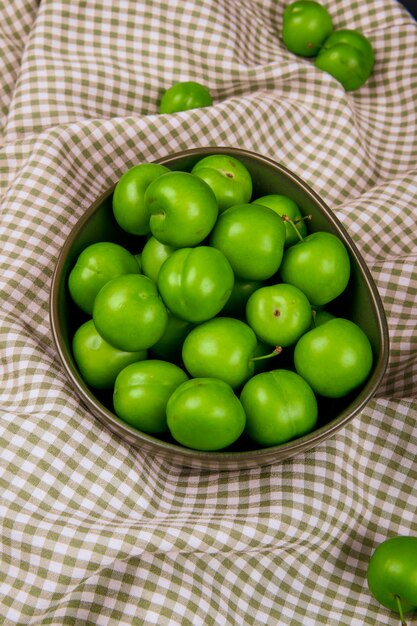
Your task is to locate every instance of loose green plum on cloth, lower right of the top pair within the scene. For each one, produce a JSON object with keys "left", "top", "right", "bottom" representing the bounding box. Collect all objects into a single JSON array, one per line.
[{"left": 315, "top": 29, "right": 375, "bottom": 91}]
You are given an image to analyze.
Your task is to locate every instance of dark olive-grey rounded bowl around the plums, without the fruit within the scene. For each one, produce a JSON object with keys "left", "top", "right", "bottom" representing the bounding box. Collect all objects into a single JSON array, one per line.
[{"left": 50, "top": 147, "right": 388, "bottom": 471}]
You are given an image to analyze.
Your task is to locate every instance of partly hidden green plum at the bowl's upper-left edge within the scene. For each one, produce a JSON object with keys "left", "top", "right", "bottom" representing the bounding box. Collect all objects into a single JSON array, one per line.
[{"left": 113, "top": 163, "right": 170, "bottom": 235}]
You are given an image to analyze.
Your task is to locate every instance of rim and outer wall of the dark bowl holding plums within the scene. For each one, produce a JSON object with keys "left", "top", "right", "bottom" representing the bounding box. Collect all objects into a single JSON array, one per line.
[{"left": 49, "top": 146, "right": 389, "bottom": 471}]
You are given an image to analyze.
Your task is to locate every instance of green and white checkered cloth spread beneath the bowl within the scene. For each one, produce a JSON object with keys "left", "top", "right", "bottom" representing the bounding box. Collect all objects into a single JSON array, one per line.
[{"left": 0, "top": 0, "right": 417, "bottom": 626}]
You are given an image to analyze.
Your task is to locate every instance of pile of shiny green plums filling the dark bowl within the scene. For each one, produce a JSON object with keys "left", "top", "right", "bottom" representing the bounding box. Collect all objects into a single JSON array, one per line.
[{"left": 68, "top": 153, "right": 372, "bottom": 451}]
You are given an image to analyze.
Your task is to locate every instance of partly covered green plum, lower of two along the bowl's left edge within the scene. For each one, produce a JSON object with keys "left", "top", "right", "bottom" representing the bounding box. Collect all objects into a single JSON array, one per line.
[{"left": 72, "top": 319, "right": 147, "bottom": 389}]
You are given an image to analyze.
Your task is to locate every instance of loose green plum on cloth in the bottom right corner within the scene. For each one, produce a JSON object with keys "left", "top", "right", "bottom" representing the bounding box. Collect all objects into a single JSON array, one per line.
[{"left": 367, "top": 535, "right": 417, "bottom": 625}]
